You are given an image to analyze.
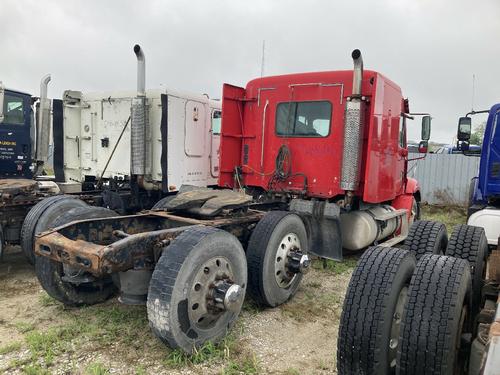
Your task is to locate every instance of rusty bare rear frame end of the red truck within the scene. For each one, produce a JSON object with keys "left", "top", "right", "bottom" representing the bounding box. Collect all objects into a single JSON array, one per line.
[{"left": 35, "top": 210, "right": 264, "bottom": 276}]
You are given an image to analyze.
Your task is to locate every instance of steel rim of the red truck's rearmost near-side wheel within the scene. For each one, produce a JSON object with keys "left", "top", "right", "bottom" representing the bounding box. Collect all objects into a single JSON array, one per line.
[{"left": 187, "top": 256, "right": 237, "bottom": 329}]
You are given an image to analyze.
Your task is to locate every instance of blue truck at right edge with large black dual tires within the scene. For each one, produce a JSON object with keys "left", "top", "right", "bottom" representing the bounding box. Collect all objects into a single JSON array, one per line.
[{"left": 337, "top": 104, "right": 500, "bottom": 375}]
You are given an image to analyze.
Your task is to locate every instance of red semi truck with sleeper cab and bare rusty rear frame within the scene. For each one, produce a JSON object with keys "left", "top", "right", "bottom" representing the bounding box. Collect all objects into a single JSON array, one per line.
[{"left": 35, "top": 50, "right": 431, "bottom": 352}]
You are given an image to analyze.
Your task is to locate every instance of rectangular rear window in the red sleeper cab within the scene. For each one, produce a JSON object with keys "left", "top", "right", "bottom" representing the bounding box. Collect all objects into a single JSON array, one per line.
[{"left": 276, "top": 101, "right": 332, "bottom": 137}]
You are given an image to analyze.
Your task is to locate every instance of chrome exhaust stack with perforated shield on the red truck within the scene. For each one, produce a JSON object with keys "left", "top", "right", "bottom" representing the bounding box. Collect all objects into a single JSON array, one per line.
[{"left": 340, "top": 49, "right": 365, "bottom": 200}]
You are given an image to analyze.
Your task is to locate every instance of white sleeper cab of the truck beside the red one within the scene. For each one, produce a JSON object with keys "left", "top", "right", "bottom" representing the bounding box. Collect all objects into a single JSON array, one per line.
[{"left": 58, "top": 89, "right": 221, "bottom": 193}]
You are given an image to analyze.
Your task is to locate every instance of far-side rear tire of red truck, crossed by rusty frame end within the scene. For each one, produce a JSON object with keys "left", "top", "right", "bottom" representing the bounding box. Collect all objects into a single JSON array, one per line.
[{"left": 35, "top": 206, "right": 118, "bottom": 306}]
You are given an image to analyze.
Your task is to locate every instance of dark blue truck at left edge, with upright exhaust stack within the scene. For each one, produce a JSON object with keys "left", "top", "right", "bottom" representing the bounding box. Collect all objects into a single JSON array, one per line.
[{"left": 0, "top": 75, "right": 58, "bottom": 257}]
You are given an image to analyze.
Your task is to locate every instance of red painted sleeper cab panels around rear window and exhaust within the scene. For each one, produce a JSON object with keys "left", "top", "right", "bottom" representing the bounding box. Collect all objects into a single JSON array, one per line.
[{"left": 219, "top": 70, "right": 418, "bottom": 207}]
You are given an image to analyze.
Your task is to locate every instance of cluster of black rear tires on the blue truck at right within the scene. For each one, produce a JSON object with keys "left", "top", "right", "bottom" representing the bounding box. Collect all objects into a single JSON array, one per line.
[{"left": 337, "top": 222, "right": 487, "bottom": 374}]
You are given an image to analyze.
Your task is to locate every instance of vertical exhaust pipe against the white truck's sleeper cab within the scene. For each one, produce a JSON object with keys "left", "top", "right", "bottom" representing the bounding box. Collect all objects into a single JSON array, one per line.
[{"left": 130, "top": 44, "right": 146, "bottom": 181}]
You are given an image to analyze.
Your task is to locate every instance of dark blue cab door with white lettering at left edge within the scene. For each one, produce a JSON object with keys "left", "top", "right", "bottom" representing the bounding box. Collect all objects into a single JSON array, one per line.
[{"left": 0, "top": 91, "right": 32, "bottom": 178}]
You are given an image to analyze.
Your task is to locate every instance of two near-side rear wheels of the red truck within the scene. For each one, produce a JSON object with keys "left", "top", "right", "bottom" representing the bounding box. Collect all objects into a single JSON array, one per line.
[{"left": 147, "top": 211, "right": 308, "bottom": 353}]
